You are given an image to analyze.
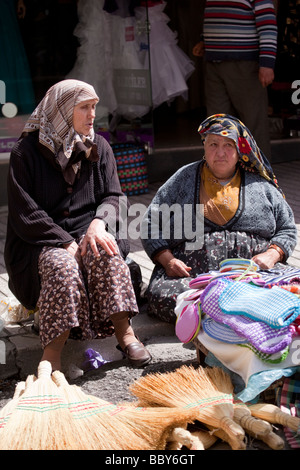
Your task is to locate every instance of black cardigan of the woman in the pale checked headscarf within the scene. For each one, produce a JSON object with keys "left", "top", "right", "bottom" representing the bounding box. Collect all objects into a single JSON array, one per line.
[{"left": 4, "top": 131, "right": 129, "bottom": 309}]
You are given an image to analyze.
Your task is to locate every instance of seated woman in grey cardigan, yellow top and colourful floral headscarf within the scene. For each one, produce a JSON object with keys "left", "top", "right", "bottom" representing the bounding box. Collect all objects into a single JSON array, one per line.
[{"left": 142, "top": 114, "right": 297, "bottom": 322}]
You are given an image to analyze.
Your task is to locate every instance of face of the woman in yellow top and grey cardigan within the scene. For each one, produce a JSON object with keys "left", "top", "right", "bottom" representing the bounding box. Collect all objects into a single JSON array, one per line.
[{"left": 204, "top": 134, "right": 239, "bottom": 180}]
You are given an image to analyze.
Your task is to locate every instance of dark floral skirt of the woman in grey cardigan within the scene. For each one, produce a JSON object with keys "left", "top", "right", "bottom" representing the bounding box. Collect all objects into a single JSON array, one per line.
[{"left": 146, "top": 230, "right": 269, "bottom": 323}]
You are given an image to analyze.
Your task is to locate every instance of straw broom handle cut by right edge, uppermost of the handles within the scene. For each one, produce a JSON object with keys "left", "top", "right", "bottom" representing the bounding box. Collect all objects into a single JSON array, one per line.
[{"left": 249, "top": 403, "right": 300, "bottom": 431}]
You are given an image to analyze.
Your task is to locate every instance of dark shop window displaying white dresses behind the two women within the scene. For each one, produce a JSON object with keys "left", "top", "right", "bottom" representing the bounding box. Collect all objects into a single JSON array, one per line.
[{"left": 0, "top": 0, "right": 300, "bottom": 167}]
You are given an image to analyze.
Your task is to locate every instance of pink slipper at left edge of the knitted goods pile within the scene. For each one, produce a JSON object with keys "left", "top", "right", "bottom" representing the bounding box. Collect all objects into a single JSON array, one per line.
[{"left": 175, "top": 302, "right": 201, "bottom": 343}]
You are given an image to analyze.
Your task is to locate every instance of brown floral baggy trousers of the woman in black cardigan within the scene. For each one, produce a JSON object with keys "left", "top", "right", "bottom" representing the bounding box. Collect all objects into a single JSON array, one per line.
[{"left": 38, "top": 245, "right": 138, "bottom": 348}]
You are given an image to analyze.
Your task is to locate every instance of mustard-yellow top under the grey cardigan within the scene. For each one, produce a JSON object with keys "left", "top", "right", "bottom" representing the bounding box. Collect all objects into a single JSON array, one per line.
[{"left": 200, "top": 164, "right": 241, "bottom": 225}]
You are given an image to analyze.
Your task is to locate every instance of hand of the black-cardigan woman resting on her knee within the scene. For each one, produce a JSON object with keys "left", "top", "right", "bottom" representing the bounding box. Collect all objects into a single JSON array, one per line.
[{"left": 80, "top": 219, "right": 119, "bottom": 257}]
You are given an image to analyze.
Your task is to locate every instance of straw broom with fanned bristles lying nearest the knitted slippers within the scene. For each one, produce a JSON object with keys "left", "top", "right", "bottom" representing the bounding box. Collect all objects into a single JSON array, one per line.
[{"left": 130, "top": 366, "right": 245, "bottom": 440}]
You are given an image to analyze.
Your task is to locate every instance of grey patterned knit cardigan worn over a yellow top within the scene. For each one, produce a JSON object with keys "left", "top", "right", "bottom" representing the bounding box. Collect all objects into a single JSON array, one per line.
[{"left": 142, "top": 161, "right": 297, "bottom": 259}]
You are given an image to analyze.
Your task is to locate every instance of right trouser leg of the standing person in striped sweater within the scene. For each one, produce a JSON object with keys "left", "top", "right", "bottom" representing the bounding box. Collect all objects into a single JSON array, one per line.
[{"left": 222, "top": 61, "right": 271, "bottom": 160}]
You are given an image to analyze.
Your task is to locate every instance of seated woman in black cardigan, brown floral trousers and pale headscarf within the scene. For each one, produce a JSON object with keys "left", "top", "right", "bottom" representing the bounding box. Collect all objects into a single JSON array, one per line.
[{"left": 5, "top": 80, "right": 151, "bottom": 369}]
